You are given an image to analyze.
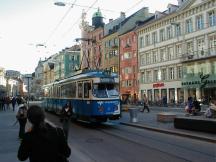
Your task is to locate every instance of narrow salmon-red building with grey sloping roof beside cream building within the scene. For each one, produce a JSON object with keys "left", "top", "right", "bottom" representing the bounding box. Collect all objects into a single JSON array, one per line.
[{"left": 118, "top": 8, "right": 151, "bottom": 103}]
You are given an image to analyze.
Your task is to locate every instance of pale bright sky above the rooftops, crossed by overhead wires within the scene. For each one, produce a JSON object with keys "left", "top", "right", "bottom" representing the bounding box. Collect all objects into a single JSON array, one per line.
[{"left": 0, "top": 0, "right": 177, "bottom": 74}]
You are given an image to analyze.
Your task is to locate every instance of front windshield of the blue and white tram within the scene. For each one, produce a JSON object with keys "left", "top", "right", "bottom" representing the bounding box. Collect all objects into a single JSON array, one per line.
[{"left": 93, "top": 83, "right": 119, "bottom": 98}]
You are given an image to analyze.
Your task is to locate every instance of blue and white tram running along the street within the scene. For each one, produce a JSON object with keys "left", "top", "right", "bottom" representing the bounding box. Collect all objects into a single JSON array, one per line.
[{"left": 42, "top": 70, "right": 121, "bottom": 122}]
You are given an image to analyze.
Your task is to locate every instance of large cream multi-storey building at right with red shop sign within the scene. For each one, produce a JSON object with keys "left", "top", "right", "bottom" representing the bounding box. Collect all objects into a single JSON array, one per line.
[{"left": 137, "top": 0, "right": 216, "bottom": 103}]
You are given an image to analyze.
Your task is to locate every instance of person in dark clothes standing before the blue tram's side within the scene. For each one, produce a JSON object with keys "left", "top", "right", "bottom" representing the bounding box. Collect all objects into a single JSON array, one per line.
[{"left": 61, "top": 102, "right": 72, "bottom": 139}]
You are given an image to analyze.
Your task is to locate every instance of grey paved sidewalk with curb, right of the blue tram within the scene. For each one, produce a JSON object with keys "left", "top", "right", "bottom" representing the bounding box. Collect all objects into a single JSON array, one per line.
[{"left": 120, "top": 106, "right": 216, "bottom": 143}]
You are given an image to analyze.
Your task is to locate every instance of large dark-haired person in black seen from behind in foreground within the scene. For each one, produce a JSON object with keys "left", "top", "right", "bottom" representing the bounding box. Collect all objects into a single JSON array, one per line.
[{"left": 17, "top": 105, "right": 71, "bottom": 162}]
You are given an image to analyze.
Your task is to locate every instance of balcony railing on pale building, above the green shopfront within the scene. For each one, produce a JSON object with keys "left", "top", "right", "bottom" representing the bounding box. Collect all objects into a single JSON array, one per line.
[{"left": 182, "top": 48, "right": 216, "bottom": 62}]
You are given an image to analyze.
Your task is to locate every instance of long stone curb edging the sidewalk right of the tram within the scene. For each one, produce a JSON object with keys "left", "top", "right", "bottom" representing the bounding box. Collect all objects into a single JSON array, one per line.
[{"left": 120, "top": 122, "right": 216, "bottom": 143}]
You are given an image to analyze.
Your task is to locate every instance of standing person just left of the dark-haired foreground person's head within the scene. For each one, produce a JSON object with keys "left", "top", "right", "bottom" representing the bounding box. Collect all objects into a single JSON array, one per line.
[{"left": 16, "top": 103, "right": 27, "bottom": 140}]
